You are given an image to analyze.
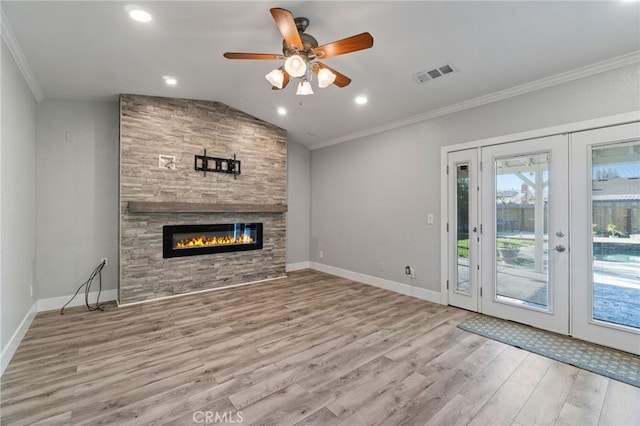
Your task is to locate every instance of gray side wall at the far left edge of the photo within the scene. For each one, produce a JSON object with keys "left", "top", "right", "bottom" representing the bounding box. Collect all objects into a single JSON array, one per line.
[{"left": 0, "top": 42, "right": 36, "bottom": 351}]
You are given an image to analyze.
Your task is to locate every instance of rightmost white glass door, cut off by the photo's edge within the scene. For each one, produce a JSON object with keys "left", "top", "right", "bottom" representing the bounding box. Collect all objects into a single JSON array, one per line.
[{"left": 571, "top": 123, "right": 640, "bottom": 354}]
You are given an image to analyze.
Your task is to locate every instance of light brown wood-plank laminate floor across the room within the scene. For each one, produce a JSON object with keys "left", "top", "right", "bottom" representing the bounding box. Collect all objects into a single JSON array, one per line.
[{"left": 0, "top": 271, "right": 640, "bottom": 426}]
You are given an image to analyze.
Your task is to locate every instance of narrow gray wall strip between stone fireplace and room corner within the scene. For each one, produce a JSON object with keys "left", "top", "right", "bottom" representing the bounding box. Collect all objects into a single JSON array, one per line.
[{"left": 287, "top": 141, "right": 311, "bottom": 265}]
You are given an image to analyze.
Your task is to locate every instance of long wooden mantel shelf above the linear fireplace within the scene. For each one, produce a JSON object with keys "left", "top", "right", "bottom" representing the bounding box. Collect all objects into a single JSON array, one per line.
[{"left": 129, "top": 201, "right": 287, "bottom": 213}]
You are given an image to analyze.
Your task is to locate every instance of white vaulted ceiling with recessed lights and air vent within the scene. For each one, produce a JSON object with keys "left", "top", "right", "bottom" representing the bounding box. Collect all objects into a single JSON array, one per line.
[{"left": 2, "top": 0, "right": 640, "bottom": 147}]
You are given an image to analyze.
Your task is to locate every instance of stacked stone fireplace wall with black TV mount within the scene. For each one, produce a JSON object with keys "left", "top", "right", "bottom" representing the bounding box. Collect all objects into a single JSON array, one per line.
[{"left": 119, "top": 95, "right": 287, "bottom": 304}]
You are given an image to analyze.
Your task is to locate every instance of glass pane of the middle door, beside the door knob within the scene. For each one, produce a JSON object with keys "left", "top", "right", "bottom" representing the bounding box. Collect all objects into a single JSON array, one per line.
[{"left": 495, "top": 153, "right": 549, "bottom": 310}]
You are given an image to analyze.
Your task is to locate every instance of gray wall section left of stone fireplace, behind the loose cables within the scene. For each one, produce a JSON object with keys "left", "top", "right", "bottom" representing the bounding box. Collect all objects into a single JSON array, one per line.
[{"left": 36, "top": 99, "right": 119, "bottom": 299}]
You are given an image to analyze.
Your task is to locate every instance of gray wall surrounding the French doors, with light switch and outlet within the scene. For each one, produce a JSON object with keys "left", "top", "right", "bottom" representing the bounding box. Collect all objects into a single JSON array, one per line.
[{"left": 310, "top": 66, "right": 640, "bottom": 292}]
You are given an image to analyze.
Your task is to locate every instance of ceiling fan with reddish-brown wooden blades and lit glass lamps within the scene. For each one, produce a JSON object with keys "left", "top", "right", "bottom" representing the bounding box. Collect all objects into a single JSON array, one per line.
[{"left": 224, "top": 7, "right": 373, "bottom": 95}]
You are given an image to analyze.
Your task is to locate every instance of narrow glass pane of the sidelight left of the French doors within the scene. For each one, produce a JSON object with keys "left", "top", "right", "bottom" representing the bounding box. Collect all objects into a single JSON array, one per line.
[{"left": 455, "top": 164, "right": 470, "bottom": 294}]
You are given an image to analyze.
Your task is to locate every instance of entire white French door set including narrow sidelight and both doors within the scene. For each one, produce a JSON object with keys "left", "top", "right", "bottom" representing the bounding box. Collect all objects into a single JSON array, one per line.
[{"left": 447, "top": 123, "right": 640, "bottom": 354}]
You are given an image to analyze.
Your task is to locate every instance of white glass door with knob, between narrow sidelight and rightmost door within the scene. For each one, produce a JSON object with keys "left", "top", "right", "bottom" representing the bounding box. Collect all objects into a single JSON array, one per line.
[{"left": 480, "top": 136, "right": 569, "bottom": 334}]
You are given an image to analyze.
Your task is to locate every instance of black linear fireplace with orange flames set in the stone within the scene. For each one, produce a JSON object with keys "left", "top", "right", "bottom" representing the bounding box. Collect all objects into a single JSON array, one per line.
[{"left": 168, "top": 223, "right": 262, "bottom": 258}]
